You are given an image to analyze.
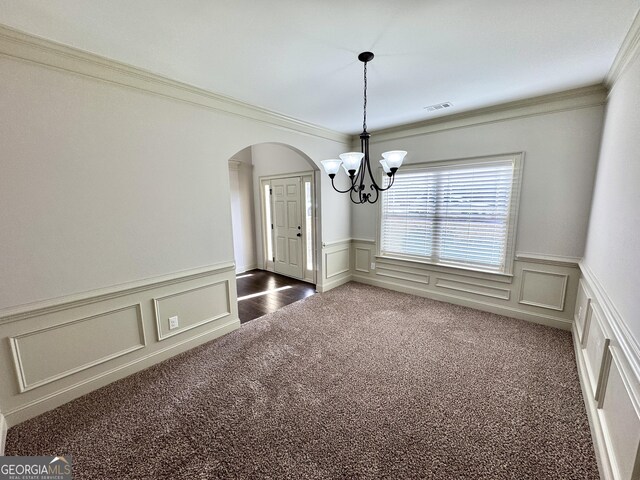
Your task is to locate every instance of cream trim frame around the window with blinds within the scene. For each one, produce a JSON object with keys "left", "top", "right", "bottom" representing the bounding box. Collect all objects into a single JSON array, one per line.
[{"left": 376, "top": 152, "right": 524, "bottom": 277}]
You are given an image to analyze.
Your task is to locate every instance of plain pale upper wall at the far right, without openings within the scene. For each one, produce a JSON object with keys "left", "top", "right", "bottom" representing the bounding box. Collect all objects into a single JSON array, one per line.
[{"left": 584, "top": 47, "right": 640, "bottom": 346}]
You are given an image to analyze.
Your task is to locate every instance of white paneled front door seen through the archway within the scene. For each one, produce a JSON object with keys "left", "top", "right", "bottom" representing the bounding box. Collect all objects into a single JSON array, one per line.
[{"left": 271, "top": 177, "right": 304, "bottom": 278}]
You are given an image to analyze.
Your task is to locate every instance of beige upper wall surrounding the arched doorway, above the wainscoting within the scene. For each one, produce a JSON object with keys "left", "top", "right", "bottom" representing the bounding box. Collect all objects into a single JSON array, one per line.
[{"left": 0, "top": 51, "right": 350, "bottom": 310}]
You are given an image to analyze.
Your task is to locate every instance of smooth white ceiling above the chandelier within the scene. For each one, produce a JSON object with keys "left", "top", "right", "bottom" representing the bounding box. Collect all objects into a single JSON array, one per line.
[{"left": 0, "top": 0, "right": 640, "bottom": 133}]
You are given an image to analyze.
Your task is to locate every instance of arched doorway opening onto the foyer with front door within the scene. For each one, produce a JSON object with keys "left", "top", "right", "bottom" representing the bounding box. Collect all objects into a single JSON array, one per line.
[{"left": 229, "top": 143, "right": 319, "bottom": 321}]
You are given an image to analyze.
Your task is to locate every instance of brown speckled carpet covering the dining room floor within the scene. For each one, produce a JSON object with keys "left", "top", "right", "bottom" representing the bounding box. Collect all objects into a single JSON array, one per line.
[{"left": 7, "top": 283, "right": 598, "bottom": 480}]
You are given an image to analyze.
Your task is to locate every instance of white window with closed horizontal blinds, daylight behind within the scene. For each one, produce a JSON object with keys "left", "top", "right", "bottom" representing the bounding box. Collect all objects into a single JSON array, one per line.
[{"left": 380, "top": 154, "right": 522, "bottom": 274}]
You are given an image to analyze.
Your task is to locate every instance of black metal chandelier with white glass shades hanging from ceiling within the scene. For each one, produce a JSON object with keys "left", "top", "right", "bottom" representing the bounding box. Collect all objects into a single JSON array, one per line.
[{"left": 321, "top": 52, "right": 407, "bottom": 203}]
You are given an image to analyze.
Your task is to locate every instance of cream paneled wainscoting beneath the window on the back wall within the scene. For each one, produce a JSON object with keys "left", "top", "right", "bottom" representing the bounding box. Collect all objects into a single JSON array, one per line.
[{"left": 352, "top": 240, "right": 580, "bottom": 330}]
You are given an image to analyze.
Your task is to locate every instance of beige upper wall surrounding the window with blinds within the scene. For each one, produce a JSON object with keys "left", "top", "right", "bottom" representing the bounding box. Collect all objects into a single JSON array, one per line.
[{"left": 352, "top": 101, "right": 603, "bottom": 259}]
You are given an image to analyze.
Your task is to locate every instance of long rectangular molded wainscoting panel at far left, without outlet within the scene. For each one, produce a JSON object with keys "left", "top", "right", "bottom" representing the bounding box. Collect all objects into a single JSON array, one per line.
[{"left": 9, "top": 304, "right": 146, "bottom": 392}]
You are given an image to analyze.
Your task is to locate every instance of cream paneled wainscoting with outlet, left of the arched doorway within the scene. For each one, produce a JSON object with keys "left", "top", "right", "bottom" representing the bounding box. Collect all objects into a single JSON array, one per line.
[{"left": 0, "top": 262, "right": 240, "bottom": 426}]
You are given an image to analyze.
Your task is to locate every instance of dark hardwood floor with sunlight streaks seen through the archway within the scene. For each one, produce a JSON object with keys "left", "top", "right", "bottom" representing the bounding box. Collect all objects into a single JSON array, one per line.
[{"left": 236, "top": 270, "right": 316, "bottom": 323}]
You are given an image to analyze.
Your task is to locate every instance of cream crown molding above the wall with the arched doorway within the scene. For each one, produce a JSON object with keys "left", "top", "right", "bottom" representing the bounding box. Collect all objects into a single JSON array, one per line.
[{"left": 0, "top": 24, "right": 351, "bottom": 143}]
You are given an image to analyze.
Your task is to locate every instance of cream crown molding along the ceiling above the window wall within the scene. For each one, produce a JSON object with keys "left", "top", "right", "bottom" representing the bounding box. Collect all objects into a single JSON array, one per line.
[{"left": 371, "top": 84, "right": 607, "bottom": 143}]
